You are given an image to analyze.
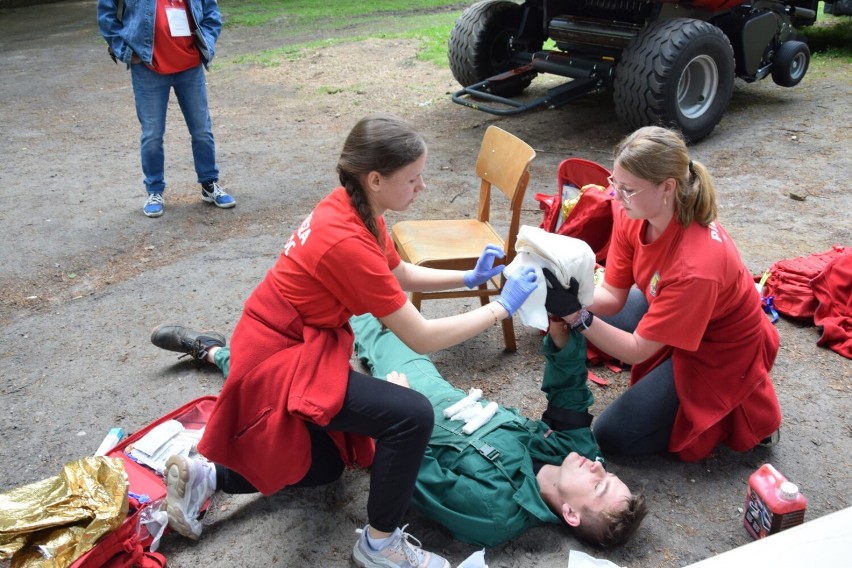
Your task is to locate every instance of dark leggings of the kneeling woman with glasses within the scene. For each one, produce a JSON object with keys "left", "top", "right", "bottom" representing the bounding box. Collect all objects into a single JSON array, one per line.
[{"left": 592, "top": 288, "right": 680, "bottom": 455}]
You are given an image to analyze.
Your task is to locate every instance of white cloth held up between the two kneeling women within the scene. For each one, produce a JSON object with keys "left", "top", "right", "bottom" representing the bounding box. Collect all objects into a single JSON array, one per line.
[{"left": 505, "top": 225, "right": 595, "bottom": 331}]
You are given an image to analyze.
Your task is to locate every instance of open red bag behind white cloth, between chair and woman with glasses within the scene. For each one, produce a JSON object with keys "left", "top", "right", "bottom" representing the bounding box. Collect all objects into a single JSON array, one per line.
[{"left": 535, "top": 158, "right": 616, "bottom": 265}]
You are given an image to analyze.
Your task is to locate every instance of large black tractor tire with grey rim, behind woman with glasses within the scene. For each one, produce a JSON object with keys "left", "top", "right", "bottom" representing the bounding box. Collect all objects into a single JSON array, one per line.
[{"left": 613, "top": 18, "right": 734, "bottom": 142}]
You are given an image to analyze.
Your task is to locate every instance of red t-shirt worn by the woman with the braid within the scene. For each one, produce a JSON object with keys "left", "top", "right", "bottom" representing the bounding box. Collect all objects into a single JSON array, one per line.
[{"left": 269, "top": 187, "right": 408, "bottom": 327}]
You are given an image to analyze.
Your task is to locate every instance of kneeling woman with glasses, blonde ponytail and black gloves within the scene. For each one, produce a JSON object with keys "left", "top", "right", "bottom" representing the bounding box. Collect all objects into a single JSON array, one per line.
[{"left": 547, "top": 127, "right": 781, "bottom": 461}]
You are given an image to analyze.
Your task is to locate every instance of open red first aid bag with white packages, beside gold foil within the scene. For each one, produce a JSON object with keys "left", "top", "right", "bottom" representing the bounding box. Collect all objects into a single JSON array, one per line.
[{"left": 71, "top": 395, "right": 216, "bottom": 568}]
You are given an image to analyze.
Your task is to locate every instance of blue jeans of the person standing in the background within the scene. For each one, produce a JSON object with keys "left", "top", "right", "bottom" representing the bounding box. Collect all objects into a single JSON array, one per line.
[{"left": 130, "top": 63, "right": 219, "bottom": 193}]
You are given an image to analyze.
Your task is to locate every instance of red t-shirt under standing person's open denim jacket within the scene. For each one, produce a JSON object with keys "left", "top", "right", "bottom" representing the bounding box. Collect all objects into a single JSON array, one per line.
[{"left": 148, "top": 0, "right": 201, "bottom": 75}]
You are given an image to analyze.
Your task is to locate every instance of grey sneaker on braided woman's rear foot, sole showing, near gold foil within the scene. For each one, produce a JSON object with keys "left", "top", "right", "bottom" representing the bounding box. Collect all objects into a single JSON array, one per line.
[{"left": 164, "top": 456, "right": 216, "bottom": 540}]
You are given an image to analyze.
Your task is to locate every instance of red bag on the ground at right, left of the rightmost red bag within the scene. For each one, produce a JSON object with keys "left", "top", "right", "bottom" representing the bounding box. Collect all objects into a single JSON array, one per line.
[{"left": 761, "top": 245, "right": 852, "bottom": 319}]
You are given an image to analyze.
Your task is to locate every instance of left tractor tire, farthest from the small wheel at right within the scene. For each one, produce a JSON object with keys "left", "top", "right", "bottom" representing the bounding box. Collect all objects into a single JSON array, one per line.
[{"left": 449, "top": 0, "right": 543, "bottom": 97}]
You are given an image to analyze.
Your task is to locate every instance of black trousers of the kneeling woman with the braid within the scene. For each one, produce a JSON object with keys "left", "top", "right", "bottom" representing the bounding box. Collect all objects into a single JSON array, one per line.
[{"left": 216, "top": 370, "right": 435, "bottom": 532}]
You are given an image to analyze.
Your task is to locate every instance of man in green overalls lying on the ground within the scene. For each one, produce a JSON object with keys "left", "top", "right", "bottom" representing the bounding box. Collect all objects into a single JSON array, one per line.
[{"left": 151, "top": 315, "right": 647, "bottom": 547}]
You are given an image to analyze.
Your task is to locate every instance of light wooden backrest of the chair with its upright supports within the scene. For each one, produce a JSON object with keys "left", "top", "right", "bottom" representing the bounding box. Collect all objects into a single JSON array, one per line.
[{"left": 476, "top": 125, "right": 535, "bottom": 264}]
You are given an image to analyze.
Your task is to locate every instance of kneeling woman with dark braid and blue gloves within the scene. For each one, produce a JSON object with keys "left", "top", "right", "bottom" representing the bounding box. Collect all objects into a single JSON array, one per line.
[{"left": 166, "top": 114, "right": 535, "bottom": 568}]
